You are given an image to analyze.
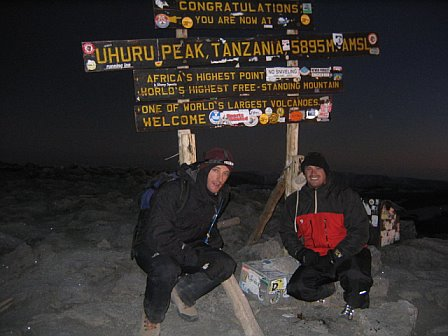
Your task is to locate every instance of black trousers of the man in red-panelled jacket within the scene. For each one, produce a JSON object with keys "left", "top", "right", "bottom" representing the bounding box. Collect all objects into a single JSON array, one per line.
[{"left": 287, "top": 248, "right": 373, "bottom": 308}]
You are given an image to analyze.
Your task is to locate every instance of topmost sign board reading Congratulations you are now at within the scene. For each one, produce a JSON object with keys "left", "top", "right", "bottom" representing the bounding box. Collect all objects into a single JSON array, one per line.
[{"left": 153, "top": 0, "right": 314, "bottom": 31}]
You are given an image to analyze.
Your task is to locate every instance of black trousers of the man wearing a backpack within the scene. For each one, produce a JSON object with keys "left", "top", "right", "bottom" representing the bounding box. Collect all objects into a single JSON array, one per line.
[{"left": 135, "top": 244, "right": 236, "bottom": 323}]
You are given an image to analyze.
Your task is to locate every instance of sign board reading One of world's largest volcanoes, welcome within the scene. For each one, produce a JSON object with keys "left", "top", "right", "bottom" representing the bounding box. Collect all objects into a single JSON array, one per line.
[{"left": 134, "top": 95, "right": 333, "bottom": 132}]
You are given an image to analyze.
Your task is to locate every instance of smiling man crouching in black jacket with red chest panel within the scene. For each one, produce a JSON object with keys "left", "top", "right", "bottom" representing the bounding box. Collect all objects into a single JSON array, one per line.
[{"left": 280, "top": 152, "right": 373, "bottom": 320}]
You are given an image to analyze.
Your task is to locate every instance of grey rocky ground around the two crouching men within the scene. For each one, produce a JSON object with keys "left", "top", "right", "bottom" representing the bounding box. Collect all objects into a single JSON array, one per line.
[{"left": 0, "top": 164, "right": 448, "bottom": 336}]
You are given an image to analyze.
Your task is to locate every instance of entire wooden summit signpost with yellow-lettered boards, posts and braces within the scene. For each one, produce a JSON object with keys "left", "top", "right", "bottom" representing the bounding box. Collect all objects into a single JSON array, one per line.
[{"left": 81, "top": 0, "right": 380, "bottom": 336}]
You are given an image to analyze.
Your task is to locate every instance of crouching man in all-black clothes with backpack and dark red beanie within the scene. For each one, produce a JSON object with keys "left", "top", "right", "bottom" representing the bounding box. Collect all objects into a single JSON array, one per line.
[{"left": 135, "top": 148, "right": 236, "bottom": 336}]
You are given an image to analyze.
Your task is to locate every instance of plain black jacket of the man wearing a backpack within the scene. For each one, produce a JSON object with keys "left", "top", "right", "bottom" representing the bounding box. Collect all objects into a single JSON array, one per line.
[{"left": 143, "top": 166, "right": 229, "bottom": 264}]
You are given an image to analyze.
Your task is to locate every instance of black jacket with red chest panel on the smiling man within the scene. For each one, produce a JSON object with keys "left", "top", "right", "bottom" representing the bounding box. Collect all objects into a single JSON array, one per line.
[{"left": 280, "top": 175, "right": 370, "bottom": 257}]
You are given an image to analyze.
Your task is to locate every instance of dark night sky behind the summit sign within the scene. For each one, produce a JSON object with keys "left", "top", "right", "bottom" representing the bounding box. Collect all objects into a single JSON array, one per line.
[{"left": 0, "top": 0, "right": 448, "bottom": 180}]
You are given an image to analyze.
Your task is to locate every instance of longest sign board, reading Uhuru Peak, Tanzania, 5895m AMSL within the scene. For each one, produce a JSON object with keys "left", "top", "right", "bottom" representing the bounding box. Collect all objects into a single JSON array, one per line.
[{"left": 82, "top": 33, "right": 380, "bottom": 72}]
